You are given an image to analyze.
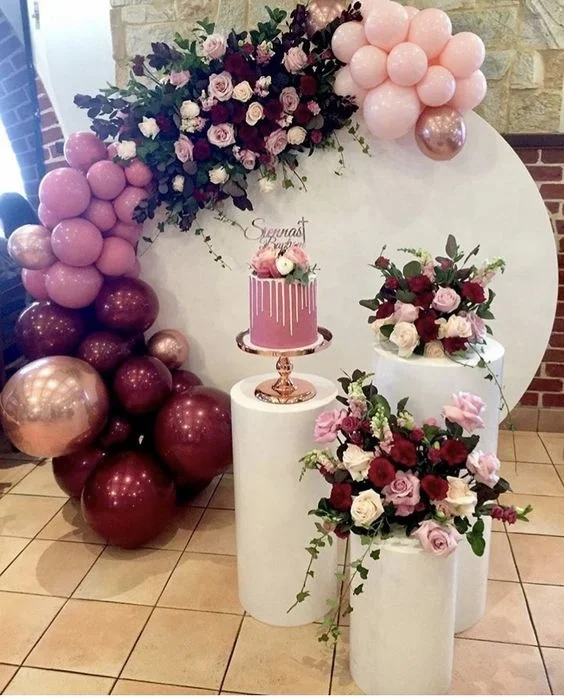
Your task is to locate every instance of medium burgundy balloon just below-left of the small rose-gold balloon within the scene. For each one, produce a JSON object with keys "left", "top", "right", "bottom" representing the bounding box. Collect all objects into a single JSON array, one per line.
[{"left": 114, "top": 357, "right": 172, "bottom": 415}]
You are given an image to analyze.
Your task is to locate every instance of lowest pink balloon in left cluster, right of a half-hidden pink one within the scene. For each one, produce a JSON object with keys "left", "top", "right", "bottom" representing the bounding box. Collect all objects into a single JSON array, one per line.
[{"left": 45, "top": 262, "right": 104, "bottom": 308}]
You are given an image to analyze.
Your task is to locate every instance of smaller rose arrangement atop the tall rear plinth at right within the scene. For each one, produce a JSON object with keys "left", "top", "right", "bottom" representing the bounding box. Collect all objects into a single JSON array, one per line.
[{"left": 360, "top": 235, "right": 505, "bottom": 358}]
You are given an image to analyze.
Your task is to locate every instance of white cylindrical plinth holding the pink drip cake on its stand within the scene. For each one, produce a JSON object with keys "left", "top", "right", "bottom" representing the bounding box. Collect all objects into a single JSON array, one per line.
[{"left": 231, "top": 374, "right": 337, "bottom": 626}]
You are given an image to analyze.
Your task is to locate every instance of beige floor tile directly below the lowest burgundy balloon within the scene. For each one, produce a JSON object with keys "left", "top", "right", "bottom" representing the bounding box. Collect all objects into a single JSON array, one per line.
[{"left": 74, "top": 548, "right": 180, "bottom": 605}]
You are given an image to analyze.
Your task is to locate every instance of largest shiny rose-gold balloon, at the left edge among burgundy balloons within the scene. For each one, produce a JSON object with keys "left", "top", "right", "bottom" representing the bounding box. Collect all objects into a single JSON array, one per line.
[{"left": 0, "top": 357, "right": 109, "bottom": 457}]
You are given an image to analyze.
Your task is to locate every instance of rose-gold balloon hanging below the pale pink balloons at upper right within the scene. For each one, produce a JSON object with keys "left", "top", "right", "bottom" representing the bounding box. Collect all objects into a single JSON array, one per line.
[{"left": 415, "top": 105, "right": 466, "bottom": 160}]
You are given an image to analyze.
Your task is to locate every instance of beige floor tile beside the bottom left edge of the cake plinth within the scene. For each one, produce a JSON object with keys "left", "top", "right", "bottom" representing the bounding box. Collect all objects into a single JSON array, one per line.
[{"left": 159, "top": 552, "right": 243, "bottom": 614}]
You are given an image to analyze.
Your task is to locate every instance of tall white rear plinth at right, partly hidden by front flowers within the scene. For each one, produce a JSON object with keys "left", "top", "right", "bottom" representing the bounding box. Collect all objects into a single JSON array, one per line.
[{"left": 373, "top": 337, "right": 505, "bottom": 633}]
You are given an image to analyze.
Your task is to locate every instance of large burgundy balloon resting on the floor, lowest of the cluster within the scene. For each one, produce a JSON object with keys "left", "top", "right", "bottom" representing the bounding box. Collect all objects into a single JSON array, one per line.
[{"left": 82, "top": 451, "right": 176, "bottom": 549}]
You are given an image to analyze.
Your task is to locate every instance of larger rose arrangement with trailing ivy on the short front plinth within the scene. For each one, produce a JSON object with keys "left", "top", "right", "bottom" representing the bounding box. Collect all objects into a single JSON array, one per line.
[{"left": 292, "top": 370, "right": 532, "bottom": 641}]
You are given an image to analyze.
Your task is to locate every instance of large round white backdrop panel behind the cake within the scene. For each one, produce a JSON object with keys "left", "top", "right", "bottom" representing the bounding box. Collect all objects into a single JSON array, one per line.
[{"left": 141, "top": 113, "right": 558, "bottom": 406}]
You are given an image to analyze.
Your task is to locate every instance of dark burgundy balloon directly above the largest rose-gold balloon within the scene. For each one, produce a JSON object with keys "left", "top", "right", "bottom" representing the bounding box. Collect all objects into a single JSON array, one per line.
[{"left": 15, "top": 301, "right": 86, "bottom": 359}]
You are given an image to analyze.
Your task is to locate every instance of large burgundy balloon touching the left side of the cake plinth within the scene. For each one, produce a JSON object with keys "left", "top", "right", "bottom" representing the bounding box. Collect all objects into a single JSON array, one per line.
[{"left": 155, "top": 386, "right": 233, "bottom": 487}]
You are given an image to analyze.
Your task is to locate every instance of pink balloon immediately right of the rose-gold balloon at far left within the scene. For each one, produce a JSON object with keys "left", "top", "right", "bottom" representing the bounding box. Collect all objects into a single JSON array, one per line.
[{"left": 51, "top": 218, "right": 104, "bottom": 267}]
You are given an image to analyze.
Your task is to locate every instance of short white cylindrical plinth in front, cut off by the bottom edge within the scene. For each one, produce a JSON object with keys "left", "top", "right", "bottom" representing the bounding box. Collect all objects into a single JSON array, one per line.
[{"left": 350, "top": 536, "right": 456, "bottom": 695}]
